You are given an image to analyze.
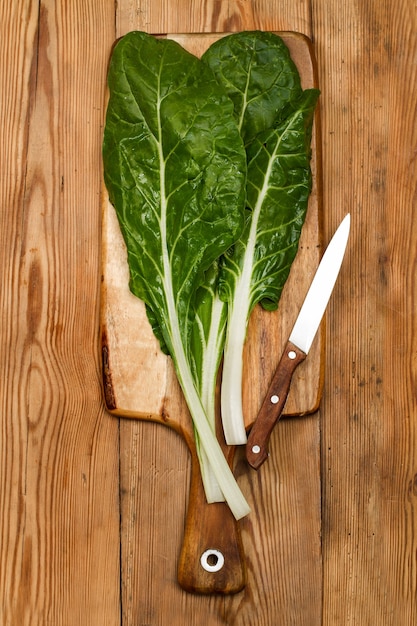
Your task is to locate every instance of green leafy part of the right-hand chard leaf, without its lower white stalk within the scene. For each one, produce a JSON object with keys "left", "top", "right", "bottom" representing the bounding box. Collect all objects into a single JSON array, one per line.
[{"left": 220, "top": 89, "right": 318, "bottom": 318}]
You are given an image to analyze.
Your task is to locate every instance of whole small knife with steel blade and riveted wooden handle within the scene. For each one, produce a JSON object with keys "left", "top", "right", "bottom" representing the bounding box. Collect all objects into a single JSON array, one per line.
[{"left": 246, "top": 213, "right": 350, "bottom": 469}]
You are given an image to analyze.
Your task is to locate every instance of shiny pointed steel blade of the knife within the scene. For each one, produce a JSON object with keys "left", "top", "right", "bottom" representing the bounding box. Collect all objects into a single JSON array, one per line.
[{"left": 289, "top": 213, "right": 350, "bottom": 354}]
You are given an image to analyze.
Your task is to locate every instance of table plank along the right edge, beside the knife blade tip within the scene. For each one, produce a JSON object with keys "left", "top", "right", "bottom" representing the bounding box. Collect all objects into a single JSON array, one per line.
[{"left": 314, "top": 0, "right": 417, "bottom": 626}]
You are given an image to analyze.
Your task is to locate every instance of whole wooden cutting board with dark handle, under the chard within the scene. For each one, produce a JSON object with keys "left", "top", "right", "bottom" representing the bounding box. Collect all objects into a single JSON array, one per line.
[{"left": 101, "top": 32, "right": 324, "bottom": 593}]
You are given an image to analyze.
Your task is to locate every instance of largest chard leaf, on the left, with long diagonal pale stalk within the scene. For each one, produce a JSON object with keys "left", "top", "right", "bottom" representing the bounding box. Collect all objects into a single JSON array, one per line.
[{"left": 103, "top": 32, "right": 249, "bottom": 518}]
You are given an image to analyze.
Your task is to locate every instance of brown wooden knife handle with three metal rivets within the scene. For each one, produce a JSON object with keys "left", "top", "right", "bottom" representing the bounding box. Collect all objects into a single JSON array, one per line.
[{"left": 246, "top": 341, "right": 307, "bottom": 469}]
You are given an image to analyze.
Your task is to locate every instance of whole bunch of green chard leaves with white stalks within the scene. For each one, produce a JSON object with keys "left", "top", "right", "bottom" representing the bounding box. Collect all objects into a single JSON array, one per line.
[{"left": 103, "top": 32, "right": 318, "bottom": 519}]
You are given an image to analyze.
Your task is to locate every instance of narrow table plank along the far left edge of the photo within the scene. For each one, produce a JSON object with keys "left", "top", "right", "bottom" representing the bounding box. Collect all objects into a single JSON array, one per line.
[{"left": 0, "top": 1, "right": 37, "bottom": 623}]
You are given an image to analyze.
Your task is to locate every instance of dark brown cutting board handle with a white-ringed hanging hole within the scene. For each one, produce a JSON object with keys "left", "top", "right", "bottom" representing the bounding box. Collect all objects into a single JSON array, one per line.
[{"left": 178, "top": 455, "right": 246, "bottom": 594}]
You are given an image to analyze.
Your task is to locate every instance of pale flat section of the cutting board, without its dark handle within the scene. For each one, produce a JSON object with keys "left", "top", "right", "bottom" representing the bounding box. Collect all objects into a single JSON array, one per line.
[{"left": 100, "top": 32, "right": 325, "bottom": 435}]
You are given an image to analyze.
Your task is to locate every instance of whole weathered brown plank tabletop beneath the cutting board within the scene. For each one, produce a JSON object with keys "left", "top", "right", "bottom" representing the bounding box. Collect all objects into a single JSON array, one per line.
[{"left": 0, "top": 0, "right": 417, "bottom": 626}]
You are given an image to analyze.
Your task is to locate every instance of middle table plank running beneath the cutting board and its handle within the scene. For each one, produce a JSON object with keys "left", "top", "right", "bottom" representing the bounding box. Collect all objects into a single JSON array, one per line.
[{"left": 118, "top": 2, "right": 321, "bottom": 626}]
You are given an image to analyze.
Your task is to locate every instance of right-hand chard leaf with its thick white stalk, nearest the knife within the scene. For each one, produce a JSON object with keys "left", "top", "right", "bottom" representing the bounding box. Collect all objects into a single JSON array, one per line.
[{"left": 221, "top": 90, "right": 318, "bottom": 438}]
